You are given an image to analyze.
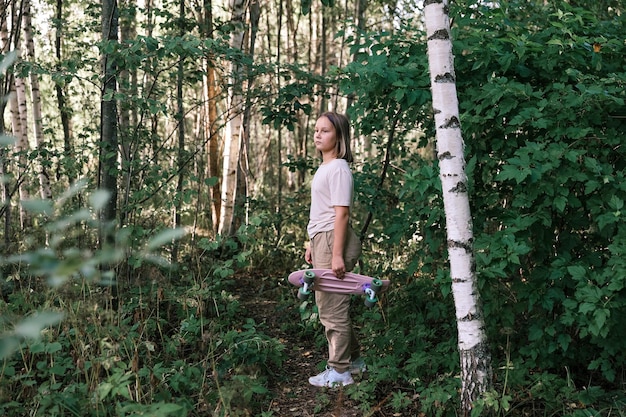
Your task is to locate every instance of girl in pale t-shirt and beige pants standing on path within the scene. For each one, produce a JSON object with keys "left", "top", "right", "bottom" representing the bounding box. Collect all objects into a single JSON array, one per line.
[{"left": 305, "top": 112, "right": 365, "bottom": 387}]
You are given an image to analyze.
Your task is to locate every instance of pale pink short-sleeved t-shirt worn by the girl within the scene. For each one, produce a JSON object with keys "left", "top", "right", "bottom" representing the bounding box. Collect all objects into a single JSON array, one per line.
[{"left": 307, "top": 159, "right": 353, "bottom": 239}]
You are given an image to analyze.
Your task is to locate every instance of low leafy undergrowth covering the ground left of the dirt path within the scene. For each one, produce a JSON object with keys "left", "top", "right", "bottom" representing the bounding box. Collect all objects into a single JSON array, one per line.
[{"left": 0, "top": 186, "right": 283, "bottom": 416}]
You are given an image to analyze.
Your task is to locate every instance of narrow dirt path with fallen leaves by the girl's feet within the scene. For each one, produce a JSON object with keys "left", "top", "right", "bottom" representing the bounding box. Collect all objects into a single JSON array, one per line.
[{"left": 237, "top": 277, "right": 378, "bottom": 417}]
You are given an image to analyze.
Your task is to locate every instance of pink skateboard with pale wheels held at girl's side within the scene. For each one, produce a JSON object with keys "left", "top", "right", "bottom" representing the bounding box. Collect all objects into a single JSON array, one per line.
[{"left": 288, "top": 269, "right": 389, "bottom": 308}]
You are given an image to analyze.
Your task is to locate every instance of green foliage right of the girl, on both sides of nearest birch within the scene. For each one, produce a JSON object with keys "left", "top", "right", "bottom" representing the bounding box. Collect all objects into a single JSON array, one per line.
[{"left": 251, "top": 2, "right": 626, "bottom": 416}]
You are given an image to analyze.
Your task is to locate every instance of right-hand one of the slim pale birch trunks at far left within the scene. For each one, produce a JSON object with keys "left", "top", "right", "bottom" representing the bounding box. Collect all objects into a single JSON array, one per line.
[{"left": 22, "top": 0, "right": 52, "bottom": 200}]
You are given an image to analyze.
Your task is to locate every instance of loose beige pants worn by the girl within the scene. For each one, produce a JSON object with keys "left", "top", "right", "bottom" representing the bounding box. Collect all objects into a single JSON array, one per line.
[{"left": 311, "top": 228, "right": 361, "bottom": 372}]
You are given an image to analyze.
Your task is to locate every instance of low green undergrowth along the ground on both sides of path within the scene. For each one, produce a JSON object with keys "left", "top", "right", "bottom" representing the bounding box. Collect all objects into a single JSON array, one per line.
[{"left": 0, "top": 193, "right": 626, "bottom": 417}]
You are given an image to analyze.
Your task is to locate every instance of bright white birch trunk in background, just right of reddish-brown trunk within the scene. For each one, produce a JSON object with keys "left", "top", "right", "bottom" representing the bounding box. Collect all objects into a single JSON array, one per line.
[{"left": 218, "top": 0, "right": 246, "bottom": 236}]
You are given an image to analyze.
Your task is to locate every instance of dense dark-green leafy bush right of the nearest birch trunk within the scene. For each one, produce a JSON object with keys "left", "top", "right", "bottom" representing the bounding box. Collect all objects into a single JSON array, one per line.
[{"left": 450, "top": 0, "right": 626, "bottom": 381}]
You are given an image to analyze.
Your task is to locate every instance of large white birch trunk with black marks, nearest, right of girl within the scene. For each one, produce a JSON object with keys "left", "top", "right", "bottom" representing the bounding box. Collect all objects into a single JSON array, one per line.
[{"left": 424, "top": 0, "right": 491, "bottom": 415}]
